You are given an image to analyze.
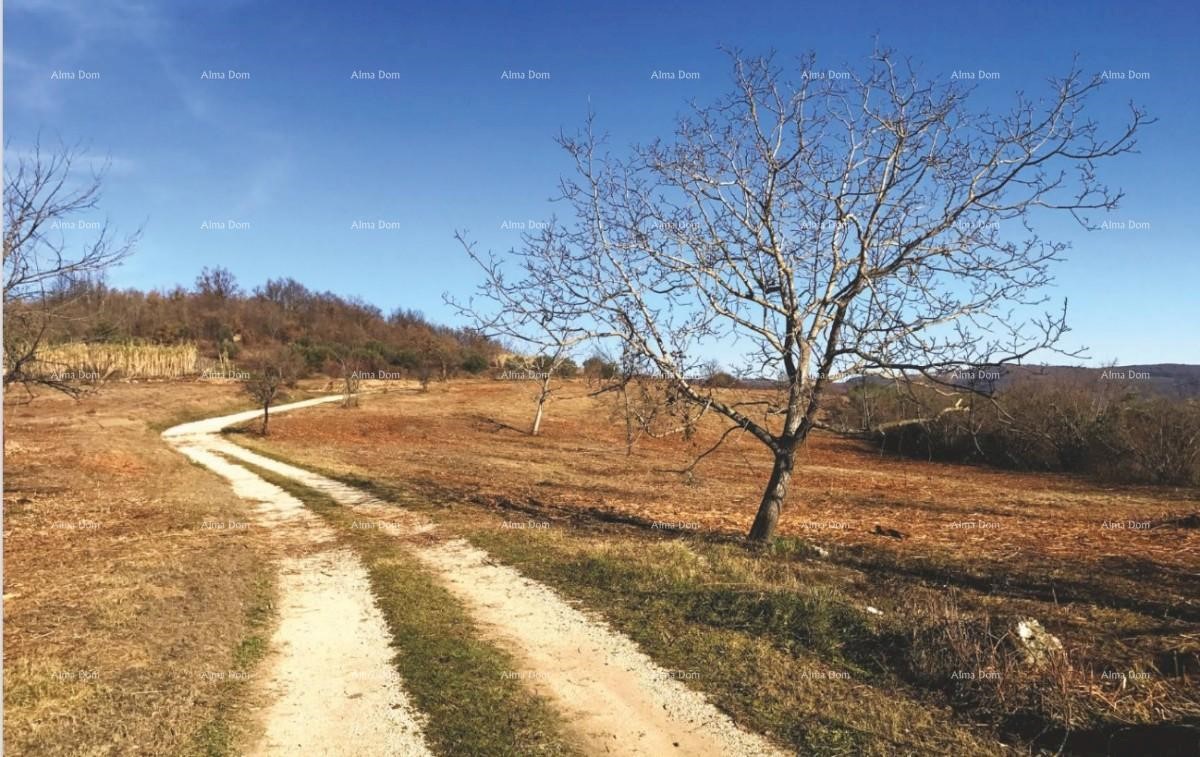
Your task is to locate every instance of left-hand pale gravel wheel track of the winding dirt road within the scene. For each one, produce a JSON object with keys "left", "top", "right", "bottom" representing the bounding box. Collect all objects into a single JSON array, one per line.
[{"left": 163, "top": 397, "right": 430, "bottom": 757}]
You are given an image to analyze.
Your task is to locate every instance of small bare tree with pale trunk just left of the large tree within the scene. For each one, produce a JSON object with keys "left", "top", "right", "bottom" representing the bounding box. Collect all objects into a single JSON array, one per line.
[{"left": 445, "top": 233, "right": 590, "bottom": 437}]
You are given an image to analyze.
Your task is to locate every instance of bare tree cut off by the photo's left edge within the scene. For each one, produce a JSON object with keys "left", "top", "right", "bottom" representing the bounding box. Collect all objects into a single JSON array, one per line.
[{"left": 4, "top": 143, "right": 140, "bottom": 396}]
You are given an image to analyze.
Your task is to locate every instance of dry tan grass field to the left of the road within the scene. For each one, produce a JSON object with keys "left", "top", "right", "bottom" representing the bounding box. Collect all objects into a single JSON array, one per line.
[{"left": 4, "top": 384, "right": 274, "bottom": 755}]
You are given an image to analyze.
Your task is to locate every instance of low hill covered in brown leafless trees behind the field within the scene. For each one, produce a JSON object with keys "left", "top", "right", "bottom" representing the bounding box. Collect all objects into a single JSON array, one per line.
[{"left": 35, "top": 269, "right": 502, "bottom": 377}]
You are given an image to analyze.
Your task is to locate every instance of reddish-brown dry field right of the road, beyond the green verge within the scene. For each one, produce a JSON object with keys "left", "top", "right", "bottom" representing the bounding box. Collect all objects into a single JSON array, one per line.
[{"left": 242, "top": 381, "right": 1200, "bottom": 748}]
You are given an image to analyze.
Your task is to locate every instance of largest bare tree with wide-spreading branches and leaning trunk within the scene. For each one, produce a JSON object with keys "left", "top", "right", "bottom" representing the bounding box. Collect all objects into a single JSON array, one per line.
[{"left": 488, "top": 50, "right": 1148, "bottom": 540}]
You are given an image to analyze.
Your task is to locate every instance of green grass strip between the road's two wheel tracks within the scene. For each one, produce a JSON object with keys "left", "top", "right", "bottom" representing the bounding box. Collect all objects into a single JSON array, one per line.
[{"left": 231, "top": 461, "right": 580, "bottom": 757}]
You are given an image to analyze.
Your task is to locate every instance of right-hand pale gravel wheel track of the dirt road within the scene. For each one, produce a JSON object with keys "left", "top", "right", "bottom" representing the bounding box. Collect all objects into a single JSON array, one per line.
[{"left": 187, "top": 402, "right": 781, "bottom": 756}]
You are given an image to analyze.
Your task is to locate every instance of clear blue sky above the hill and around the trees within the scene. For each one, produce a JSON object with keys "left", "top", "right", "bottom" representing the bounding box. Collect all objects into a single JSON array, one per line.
[{"left": 4, "top": 0, "right": 1200, "bottom": 365}]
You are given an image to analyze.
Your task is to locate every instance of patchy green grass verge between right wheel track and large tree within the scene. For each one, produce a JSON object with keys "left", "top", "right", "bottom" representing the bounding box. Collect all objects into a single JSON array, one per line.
[{"left": 218, "top": 444, "right": 1001, "bottom": 756}]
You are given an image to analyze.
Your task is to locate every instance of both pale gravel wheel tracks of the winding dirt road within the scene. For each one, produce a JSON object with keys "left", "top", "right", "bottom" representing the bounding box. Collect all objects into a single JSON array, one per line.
[{"left": 163, "top": 397, "right": 781, "bottom": 756}]
